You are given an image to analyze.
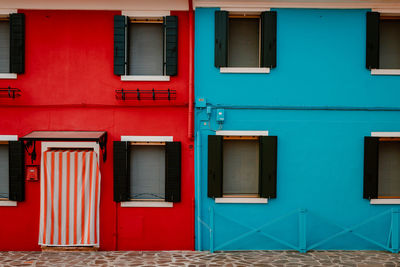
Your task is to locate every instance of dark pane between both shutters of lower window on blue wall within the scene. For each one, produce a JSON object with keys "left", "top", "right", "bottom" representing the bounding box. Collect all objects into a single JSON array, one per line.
[{"left": 223, "top": 140, "right": 259, "bottom": 195}]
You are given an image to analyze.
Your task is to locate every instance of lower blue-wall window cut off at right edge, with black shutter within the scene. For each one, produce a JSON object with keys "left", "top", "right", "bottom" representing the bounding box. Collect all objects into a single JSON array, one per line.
[{"left": 364, "top": 137, "right": 400, "bottom": 203}]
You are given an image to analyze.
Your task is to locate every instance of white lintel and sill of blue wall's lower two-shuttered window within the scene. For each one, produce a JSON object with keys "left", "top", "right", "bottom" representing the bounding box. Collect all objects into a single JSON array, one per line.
[{"left": 215, "top": 131, "right": 268, "bottom": 204}]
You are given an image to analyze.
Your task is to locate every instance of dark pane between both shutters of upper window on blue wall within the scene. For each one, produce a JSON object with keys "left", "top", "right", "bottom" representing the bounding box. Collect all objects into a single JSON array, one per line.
[{"left": 228, "top": 19, "right": 260, "bottom": 67}]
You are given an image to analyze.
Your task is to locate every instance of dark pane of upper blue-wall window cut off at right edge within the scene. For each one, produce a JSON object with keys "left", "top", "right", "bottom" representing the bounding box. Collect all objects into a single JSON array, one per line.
[{"left": 379, "top": 20, "right": 400, "bottom": 69}]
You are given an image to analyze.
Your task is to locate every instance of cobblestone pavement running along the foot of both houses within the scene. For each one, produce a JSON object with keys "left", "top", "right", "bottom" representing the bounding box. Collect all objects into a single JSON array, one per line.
[{"left": 0, "top": 251, "right": 400, "bottom": 267}]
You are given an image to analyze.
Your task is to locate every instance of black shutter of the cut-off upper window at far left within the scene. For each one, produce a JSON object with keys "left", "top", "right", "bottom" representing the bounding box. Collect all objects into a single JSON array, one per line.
[{"left": 10, "top": 13, "right": 25, "bottom": 74}]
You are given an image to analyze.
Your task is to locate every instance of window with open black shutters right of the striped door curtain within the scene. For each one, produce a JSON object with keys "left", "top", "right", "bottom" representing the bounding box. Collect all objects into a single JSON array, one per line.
[{"left": 114, "top": 137, "right": 181, "bottom": 206}]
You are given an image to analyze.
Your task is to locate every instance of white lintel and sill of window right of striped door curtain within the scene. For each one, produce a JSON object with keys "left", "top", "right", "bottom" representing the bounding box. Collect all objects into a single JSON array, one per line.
[{"left": 121, "top": 135, "right": 174, "bottom": 208}]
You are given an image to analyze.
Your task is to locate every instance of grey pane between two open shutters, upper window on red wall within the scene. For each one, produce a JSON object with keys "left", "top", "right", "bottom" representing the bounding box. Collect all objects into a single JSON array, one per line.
[{"left": 129, "top": 23, "right": 164, "bottom": 75}]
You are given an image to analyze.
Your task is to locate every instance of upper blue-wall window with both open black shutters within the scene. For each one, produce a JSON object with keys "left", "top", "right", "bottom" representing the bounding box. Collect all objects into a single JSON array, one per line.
[{"left": 215, "top": 11, "right": 276, "bottom": 72}]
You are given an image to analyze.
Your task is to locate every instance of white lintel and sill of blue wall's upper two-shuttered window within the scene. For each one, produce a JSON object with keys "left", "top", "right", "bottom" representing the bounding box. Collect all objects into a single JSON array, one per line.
[{"left": 219, "top": 7, "right": 271, "bottom": 74}]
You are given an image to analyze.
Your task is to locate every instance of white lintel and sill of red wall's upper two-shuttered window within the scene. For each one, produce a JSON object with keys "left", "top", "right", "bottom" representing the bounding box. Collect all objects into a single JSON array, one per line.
[{"left": 121, "top": 10, "right": 171, "bottom": 82}]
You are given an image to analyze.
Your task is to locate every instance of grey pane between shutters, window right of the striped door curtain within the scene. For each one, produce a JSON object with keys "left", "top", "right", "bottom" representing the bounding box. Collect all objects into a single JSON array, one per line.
[{"left": 130, "top": 145, "right": 165, "bottom": 199}]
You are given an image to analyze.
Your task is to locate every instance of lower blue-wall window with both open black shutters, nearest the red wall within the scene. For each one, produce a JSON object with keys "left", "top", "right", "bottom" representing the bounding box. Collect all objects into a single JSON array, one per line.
[{"left": 208, "top": 133, "right": 277, "bottom": 203}]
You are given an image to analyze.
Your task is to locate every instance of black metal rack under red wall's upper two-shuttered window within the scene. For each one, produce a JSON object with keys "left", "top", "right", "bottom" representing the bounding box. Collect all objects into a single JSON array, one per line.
[{"left": 115, "top": 88, "right": 176, "bottom": 101}]
